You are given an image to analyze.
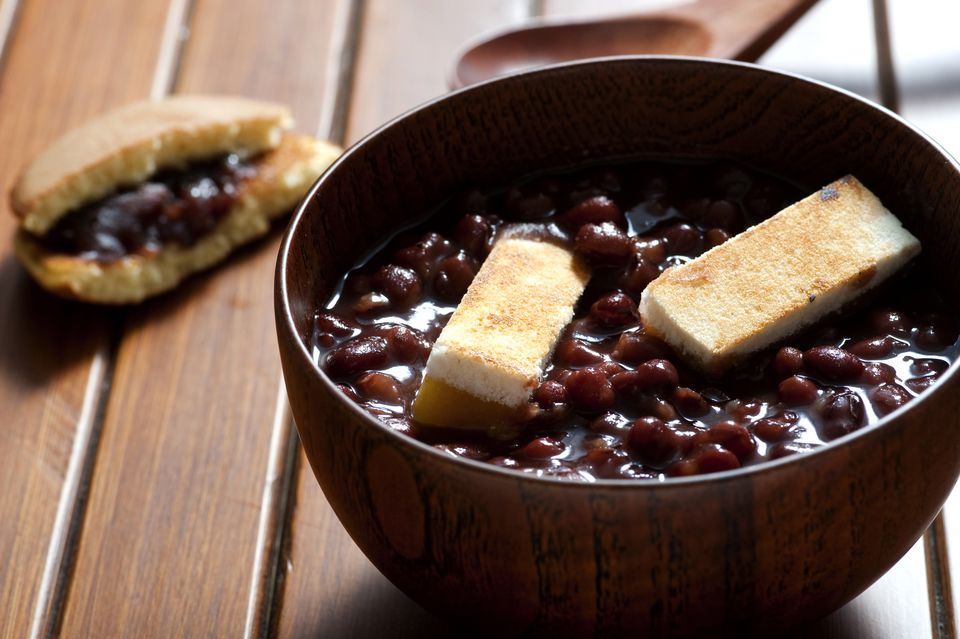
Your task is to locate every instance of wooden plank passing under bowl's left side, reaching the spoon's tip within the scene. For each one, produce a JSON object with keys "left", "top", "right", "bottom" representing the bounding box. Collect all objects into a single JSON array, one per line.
[{"left": 274, "top": 0, "right": 529, "bottom": 639}]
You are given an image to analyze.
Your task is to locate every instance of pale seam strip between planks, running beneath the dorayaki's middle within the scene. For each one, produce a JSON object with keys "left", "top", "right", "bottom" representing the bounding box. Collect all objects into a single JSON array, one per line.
[{"left": 28, "top": 0, "right": 193, "bottom": 639}]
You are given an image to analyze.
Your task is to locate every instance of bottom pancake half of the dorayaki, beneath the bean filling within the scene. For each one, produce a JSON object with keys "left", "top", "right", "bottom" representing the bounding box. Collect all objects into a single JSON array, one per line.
[{"left": 14, "top": 134, "right": 340, "bottom": 304}]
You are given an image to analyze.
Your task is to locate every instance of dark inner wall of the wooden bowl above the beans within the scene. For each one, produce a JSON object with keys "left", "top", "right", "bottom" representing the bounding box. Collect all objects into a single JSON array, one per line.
[{"left": 280, "top": 56, "right": 960, "bottom": 364}]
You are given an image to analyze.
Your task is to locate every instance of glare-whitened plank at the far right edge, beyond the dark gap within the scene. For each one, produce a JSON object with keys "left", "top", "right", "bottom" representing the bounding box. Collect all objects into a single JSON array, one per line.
[{"left": 888, "top": 0, "right": 960, "bottom": 637}]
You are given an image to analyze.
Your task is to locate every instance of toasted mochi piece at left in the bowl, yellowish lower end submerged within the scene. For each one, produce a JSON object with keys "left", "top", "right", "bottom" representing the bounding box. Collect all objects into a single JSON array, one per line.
[{"left": 413, "top": 236, "right": 590, "bottom": 428}]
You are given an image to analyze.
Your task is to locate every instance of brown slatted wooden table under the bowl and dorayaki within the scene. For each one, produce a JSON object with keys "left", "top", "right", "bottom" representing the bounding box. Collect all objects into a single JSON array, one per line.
[{"left": 0, "top": 0, "right": 960, "bottom": 638}]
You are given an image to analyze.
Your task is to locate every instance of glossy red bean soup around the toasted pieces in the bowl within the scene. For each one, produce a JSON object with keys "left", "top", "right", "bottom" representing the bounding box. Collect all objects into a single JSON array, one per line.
[{"left": 313, "top": 162, "right": 958, "bottom": 481}]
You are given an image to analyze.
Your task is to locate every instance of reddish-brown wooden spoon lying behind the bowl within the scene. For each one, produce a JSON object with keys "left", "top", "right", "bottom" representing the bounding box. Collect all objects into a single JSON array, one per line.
[{"left": 447, "top": 0, "right": 817, "bottom": 89}]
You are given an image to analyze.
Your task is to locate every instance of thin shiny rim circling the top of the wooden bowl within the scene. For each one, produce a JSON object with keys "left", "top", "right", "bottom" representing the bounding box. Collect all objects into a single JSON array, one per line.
[{"left": 274, "top": 55, "right": 960, "bottom": 491}]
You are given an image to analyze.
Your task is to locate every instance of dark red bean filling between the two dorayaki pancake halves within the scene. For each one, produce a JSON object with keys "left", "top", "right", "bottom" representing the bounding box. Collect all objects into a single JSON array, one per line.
[{"left": 41, "top": 154, "right": 256, "bottom": 262}]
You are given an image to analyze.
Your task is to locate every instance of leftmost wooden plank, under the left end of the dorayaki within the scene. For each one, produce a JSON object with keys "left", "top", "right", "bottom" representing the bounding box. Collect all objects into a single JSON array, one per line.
[{"left": 0, "top": 0, "right": 174, "bottom": 636}]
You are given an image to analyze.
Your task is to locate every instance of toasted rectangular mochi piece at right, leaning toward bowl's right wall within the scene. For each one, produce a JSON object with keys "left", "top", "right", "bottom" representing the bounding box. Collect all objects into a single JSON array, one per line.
[{"left": 640, "top": 175, "right": 920, "bottom": 374}]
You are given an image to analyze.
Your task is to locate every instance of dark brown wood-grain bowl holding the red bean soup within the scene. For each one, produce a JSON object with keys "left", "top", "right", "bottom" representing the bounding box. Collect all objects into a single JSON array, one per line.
[{"left": 276, "top": 57, "right": 960, "bottom": 637}]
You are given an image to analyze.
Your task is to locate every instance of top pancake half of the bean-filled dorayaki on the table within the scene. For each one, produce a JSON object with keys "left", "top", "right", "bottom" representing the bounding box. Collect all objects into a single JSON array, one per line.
[{"left": 10, "top": 95, "right": 292, "bottom": 235}]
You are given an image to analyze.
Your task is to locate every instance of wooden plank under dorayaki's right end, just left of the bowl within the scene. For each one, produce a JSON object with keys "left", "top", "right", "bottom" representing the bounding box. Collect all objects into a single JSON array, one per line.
[{"left": 54, "top": 0, "right": 344, "bottom": 636}]
